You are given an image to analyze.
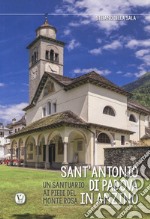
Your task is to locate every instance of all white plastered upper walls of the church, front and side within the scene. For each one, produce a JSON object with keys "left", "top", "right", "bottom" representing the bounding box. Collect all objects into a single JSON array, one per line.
[{"left": 26, "top": 80, "right": 148, "bottom": 145}]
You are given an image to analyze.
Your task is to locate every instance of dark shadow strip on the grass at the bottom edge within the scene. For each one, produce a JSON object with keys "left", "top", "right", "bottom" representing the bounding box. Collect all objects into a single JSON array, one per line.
[{"left": 11, "top": 213, "right": 56, "bottom": 219}]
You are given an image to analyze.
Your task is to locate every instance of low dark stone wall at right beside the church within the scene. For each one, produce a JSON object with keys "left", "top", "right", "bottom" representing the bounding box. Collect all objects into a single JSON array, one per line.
[{"left": 104, "top": 146, "right": 150, "bottom": 177}]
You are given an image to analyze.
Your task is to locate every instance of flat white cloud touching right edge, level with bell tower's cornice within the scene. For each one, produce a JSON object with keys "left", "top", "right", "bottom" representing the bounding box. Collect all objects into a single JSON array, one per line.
[{"left": 126, "top": 39, "right": 150, "bottom": 49}]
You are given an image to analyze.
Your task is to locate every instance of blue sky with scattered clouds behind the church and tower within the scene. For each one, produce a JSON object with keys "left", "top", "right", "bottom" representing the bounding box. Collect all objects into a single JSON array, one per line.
[{"left": 0, "top": 0, "right": 150, "bottom": 122}]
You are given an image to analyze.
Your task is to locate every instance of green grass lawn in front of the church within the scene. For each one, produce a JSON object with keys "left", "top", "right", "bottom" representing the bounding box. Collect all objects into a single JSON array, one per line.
[{"left": 0, "top": 165, "right": 149, "bottom": 219}]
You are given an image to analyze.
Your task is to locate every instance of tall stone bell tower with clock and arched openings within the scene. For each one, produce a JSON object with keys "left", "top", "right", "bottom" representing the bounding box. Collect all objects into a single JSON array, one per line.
[{"left": 27, "top": 18, "right": 65, "bottom": 102}]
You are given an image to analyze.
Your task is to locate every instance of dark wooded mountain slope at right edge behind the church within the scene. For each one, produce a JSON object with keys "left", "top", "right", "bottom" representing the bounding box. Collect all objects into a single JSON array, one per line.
[{"left": 123, "top": 72, "right": 150, "bottom": 107}]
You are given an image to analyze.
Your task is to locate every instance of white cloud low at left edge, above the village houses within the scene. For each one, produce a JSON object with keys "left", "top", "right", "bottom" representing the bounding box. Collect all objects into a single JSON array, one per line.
[{"left": 0, "top": 103, "right": 27, "bottom": 124}]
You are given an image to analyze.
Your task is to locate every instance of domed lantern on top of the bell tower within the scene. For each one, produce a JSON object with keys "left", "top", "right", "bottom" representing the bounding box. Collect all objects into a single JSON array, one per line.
[{"left": 36, "top": 19, "right": 57, "bottom": 39}]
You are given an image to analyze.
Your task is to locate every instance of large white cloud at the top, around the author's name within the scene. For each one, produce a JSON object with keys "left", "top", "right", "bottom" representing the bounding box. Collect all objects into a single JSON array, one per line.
[{"left": 57, "top": 0, "right": 150, "bottom": 31}]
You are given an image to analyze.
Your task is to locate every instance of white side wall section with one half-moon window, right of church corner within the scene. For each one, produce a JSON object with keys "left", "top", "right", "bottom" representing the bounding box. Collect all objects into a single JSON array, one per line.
[{"left": 88, "top": 84, "right": 127, "bottom": 129}]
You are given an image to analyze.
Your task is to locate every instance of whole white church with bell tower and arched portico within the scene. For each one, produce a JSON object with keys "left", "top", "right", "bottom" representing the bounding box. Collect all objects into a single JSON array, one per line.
[{"left": 9, "top": 20, "right": 150, "bottom": 168}]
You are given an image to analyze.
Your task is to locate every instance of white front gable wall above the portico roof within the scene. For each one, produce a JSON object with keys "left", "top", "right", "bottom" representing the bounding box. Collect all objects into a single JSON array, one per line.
[{"left": 26, "top": 83, "right": 88, "bottom": 125}]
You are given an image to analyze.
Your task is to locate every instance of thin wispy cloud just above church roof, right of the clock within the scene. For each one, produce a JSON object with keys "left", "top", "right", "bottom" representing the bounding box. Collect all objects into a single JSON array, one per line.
[{"left": 74, "top": 68, "right": 111, "bottom": 75}]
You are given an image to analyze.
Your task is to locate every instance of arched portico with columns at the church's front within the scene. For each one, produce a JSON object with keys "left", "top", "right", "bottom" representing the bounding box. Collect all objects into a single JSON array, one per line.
[{"left": 12, "top": 127, "right": 90, "bottom": 169}]
